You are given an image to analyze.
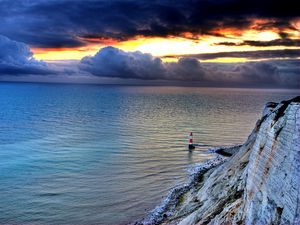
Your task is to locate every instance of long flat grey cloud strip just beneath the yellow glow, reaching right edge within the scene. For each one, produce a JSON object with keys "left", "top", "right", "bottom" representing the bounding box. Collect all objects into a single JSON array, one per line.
[{"left": 164, "top": 49, "right": 300, "bottom": 60}]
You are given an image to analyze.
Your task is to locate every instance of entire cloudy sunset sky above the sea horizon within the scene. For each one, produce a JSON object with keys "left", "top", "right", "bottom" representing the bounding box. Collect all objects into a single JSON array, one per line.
[{"left": 0, "top": 0, "right": 300, "bottom": 88}]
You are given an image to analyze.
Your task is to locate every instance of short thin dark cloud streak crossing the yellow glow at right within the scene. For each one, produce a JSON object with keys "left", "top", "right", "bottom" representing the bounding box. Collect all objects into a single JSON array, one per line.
[{"left": 216, "top": 38, "right": 300, "bottom": 47}]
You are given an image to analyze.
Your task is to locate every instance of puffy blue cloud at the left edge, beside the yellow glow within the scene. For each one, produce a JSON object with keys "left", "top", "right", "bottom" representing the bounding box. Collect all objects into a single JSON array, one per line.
[{"left": 0, "top": 35, "right": 54, "bottom": 75}]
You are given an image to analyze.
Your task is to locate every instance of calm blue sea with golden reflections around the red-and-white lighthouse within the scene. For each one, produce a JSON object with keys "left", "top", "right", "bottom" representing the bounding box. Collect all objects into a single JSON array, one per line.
[{"left": 0, "top": 83, "right": 299, "bottom": 224}]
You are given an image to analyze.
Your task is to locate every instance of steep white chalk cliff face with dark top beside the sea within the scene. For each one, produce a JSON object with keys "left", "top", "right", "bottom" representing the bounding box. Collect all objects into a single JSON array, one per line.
[{"left": 142, "top": 97, "right": 300, "bottom": 225}]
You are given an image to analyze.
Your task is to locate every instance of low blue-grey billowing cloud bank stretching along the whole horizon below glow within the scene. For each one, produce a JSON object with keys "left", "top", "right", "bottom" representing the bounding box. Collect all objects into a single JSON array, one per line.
[{"left": 0, "top": 36, "right": 300, "bottom": 88}]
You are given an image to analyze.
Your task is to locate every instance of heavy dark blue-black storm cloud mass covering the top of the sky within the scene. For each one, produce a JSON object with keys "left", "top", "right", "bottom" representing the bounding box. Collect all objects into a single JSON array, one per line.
[{"left": 0, "top": 0, "right": 299, "bottom": 47}]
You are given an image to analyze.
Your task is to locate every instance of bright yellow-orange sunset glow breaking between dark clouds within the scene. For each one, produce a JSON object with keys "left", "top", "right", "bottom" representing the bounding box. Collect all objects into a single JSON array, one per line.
[{"left": 32, "top": 28, "right": 299, "bottom": 62}]
